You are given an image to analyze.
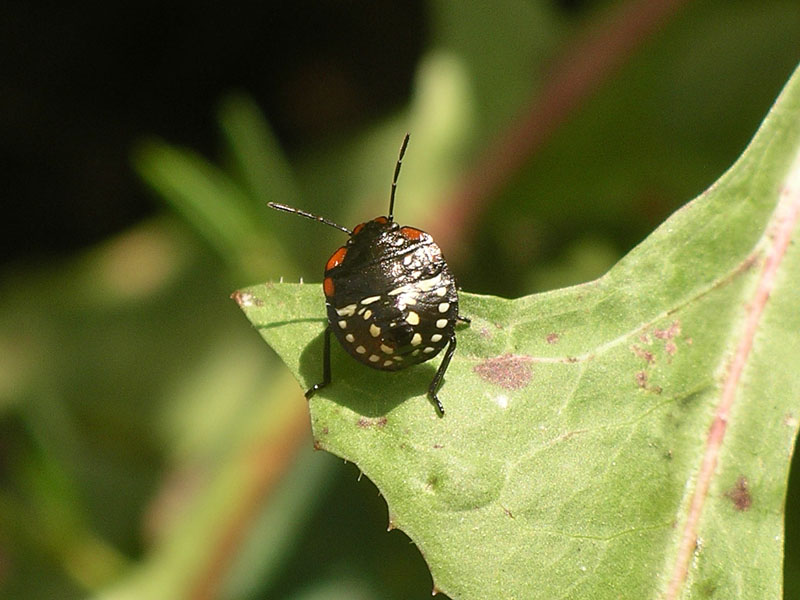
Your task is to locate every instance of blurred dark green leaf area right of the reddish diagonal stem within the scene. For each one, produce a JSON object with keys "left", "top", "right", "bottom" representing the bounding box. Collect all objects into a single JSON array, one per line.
[{"left": 468, "top": 0, "right": 800, "bottom": 296}]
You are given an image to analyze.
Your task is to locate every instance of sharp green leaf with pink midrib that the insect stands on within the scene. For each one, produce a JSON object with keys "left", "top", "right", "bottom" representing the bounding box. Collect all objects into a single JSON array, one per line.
[{"left": 234, "top": 63, "right": 800, "bottom": 600}]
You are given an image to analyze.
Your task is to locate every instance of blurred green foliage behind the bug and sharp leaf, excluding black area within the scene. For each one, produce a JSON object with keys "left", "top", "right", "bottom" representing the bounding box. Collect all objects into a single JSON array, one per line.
[{"left": 0, "top": 0, "right": 800, "bottom": 599}]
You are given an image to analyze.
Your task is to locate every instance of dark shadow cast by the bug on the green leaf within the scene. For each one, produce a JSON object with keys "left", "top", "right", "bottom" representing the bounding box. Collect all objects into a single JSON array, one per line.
[{"left": 299, "top": 333, "right": 438, "bottom": 417}]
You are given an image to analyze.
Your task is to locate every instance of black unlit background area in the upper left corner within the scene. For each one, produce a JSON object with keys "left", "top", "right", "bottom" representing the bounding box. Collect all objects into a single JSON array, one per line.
[{"left": 0, "top": 1, "right": 428, "bottom": 260}]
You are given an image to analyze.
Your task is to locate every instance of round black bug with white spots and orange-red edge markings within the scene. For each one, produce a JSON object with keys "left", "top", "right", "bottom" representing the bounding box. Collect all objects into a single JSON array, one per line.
[{"left": 269, "top": 134, "right": 470, "bottom": 415}]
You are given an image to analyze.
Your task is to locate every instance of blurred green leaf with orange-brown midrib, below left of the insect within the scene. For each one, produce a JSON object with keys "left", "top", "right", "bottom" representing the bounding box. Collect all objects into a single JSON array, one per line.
[{"left": 96, "top": 376, "right": 330, "bottom": 600}]
